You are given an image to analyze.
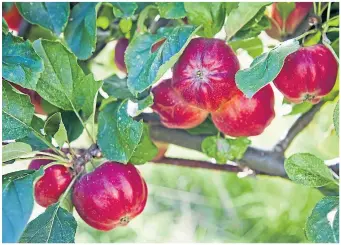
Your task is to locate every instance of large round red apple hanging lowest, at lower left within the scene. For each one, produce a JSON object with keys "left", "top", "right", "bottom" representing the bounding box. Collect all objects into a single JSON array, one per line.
[{"left": 72, "top": 162, "right": 148, "bottom": 231}]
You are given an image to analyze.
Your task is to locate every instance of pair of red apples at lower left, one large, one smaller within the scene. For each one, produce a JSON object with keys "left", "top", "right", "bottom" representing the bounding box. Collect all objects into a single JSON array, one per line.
[{"left": 28, "top": 150, "right": 148, "bottom": 231}]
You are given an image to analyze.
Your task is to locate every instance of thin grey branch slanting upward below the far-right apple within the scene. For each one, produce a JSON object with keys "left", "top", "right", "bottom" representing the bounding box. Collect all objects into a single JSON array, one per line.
[{"left": 274, "top": 102, "right": 325, "bottom": 153}]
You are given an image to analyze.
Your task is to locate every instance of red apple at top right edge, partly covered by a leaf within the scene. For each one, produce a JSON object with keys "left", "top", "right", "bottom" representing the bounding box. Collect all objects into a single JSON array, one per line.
[{"left": 266, "top": 2, "right": 313, "bottom": 40}]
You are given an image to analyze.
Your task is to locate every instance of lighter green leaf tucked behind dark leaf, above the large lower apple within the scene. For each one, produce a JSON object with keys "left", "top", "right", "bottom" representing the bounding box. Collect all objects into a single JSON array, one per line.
[{"left": 129, "top": 124, "right": 159, "bottom": 164}]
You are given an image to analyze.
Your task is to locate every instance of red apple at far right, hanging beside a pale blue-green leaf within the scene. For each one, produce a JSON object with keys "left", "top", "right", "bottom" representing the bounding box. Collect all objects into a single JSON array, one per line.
[{"left": 274, "top": 44, "right": 338, "bottom": 104}]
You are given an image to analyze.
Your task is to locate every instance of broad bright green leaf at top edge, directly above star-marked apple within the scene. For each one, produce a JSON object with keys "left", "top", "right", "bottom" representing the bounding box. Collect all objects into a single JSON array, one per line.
[{"left": 184, "top": 2, "right": 226, "bottom": 38}]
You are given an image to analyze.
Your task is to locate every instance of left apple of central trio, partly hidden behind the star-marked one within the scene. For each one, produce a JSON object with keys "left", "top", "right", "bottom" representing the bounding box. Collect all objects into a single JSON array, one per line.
[{"left": 152, "top": 79, "right": 208, "bottom": 129}]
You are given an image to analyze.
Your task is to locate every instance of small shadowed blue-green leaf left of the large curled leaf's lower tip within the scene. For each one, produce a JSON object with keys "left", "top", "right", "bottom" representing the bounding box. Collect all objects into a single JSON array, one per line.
[{"left": 102, "top": 75, "right": 134, "bottom": 99}]
